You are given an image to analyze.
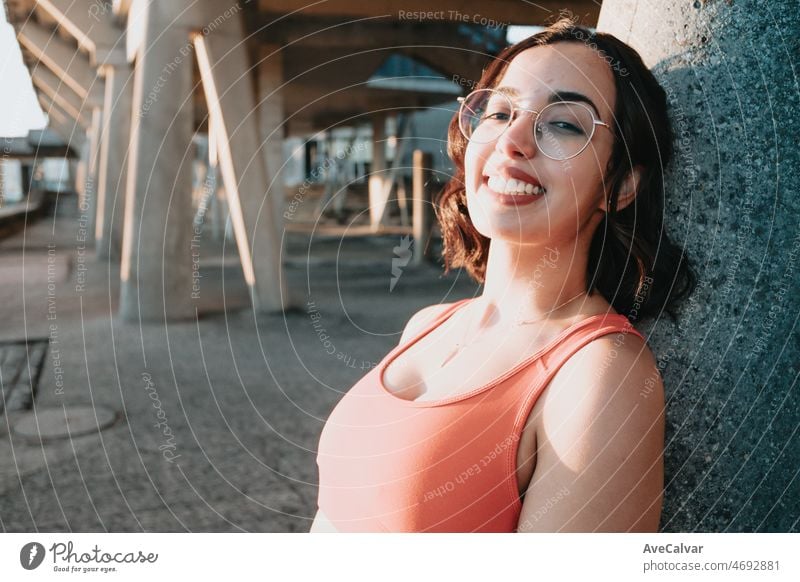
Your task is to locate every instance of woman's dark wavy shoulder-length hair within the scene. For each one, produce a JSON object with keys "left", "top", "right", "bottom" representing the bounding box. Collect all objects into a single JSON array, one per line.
[{"left": 435, "top": 18, "right": 696, "bottom": 321}]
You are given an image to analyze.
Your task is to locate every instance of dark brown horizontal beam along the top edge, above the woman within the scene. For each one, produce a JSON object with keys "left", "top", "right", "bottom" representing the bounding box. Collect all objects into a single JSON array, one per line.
[{"left": 258, "top": 0, "right": 600, "bottom": 26}]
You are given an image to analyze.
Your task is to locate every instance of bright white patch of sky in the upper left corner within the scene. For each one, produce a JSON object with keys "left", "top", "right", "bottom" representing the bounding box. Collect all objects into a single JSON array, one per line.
[{"left": 0, "top": 2, "right": 47, "bottom": 137}]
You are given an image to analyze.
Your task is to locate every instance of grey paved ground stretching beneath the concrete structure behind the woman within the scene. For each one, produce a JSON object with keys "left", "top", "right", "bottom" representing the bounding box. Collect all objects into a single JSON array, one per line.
[{"left": 0, "top": 210, "right": 475, "bottom": 532}]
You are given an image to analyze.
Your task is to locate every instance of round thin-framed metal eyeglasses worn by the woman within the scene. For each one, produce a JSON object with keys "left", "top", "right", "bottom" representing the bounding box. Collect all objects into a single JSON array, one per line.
[{"left": 458, "top": 89, "right": 611, "bottom": 160}]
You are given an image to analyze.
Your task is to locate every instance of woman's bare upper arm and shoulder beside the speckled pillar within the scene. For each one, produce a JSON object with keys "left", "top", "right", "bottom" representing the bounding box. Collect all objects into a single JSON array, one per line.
[{"left": 518, "top": 335, "right": 664, "bottom": 532}]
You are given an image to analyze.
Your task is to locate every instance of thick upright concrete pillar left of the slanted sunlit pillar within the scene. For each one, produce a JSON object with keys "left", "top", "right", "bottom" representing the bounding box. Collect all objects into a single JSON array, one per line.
[{"left": 120, "top": 2, "right": 194, "bottom": 321}]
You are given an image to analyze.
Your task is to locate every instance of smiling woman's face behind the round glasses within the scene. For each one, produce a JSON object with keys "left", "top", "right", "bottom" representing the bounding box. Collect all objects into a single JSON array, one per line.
[{"left": 464, "top": 42, "right": 616, "bottom": 245}]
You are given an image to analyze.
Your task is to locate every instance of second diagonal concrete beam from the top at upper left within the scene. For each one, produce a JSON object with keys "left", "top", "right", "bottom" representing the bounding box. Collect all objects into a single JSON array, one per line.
[{"left": 17, "top": 20, "right": 103, "bottom": 105}]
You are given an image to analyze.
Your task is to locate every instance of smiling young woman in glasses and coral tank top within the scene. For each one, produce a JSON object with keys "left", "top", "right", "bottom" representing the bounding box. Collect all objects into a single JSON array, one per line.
[{"left": 311, "top": 20, "right": 694, "bottom": 532}]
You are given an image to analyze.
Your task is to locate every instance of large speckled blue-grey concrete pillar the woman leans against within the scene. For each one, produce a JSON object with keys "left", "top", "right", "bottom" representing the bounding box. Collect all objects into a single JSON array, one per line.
[{"left": 597, "top": 0, "right": 800, "bottom": 532}]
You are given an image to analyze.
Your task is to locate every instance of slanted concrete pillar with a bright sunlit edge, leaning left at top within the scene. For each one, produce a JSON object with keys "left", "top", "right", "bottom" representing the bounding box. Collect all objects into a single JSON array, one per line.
[{"left": 193, "top": 17, "right": 289, "bottom": 312}]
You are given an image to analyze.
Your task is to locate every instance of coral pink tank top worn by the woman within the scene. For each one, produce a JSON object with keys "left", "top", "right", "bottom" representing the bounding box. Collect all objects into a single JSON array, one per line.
[{"left": 317, "top": 299, "right": 642, "bottom": 532}]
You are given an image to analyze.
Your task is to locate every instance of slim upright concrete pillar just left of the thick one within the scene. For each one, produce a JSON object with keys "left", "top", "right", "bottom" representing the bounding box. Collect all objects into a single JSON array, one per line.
[{"left": 95, "top": 65, "right": 133, "bottom": 260}]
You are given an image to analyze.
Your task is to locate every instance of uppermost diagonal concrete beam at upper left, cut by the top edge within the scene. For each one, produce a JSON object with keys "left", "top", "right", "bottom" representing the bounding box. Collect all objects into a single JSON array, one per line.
[{"left": 36, "top": 0, "right": 127, "bottom": 66}]
